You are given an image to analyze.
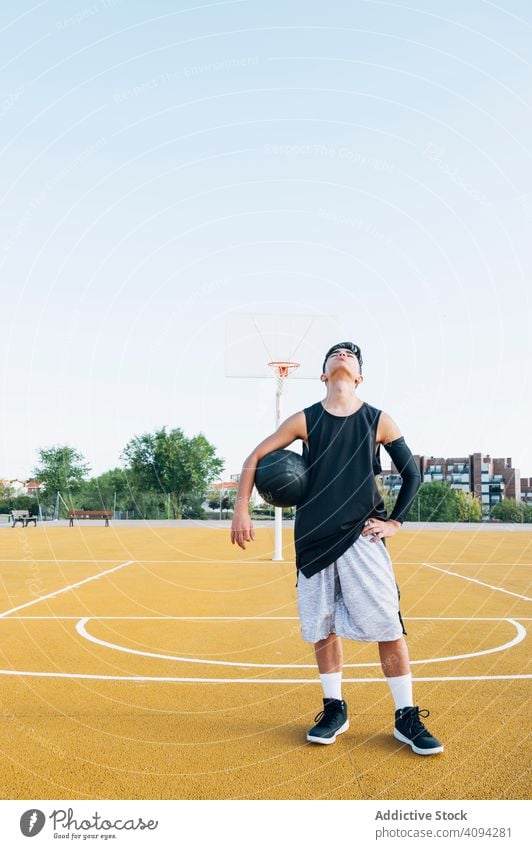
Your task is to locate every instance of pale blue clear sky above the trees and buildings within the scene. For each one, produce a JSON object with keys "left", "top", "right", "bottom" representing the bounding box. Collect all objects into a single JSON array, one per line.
[{"left": 0, "top": 0, "right": 532, "bottom": 477}]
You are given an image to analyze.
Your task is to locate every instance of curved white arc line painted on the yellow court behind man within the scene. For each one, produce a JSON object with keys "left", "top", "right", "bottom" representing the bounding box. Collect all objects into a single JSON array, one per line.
[{"left": 76, "top": 616, "right": 527, "bottom": 669}]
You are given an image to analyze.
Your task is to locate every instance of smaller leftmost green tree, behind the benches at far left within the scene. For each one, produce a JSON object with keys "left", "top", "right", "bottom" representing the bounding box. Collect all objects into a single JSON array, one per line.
[{"left": 31, "top": 445, "right": 89, "bottom": 506}]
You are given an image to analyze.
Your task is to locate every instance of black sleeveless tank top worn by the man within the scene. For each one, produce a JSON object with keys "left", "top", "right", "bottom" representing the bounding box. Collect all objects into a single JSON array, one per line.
[{"left": 294, "top": 402, "right": 386, "bottom": 578}]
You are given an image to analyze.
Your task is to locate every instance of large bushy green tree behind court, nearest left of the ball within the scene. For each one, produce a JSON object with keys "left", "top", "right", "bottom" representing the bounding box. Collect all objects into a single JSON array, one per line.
[{"left": 122, "top": 427, "right": 224, "bottom": 519}]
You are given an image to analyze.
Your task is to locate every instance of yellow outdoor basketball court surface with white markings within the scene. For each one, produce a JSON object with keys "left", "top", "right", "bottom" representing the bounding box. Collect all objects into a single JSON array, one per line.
[{"left": 0, "top": 525, "right": 532, "bottom": 799}]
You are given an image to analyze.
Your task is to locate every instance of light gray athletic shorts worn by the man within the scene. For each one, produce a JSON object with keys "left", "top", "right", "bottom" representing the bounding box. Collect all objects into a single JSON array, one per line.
[{"left": 297, "top": 536, "right": 405, "bottom": 643}]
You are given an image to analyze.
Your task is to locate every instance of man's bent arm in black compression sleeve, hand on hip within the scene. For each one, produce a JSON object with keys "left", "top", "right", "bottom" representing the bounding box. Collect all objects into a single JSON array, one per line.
[{"left": 362, "top": 413, "right": 421, "bottom": 542}]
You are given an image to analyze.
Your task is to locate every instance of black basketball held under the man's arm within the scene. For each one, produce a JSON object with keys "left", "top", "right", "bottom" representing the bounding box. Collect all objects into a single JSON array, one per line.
[{"left": 255, "top": 449, "right": 308, "bottom": 507}]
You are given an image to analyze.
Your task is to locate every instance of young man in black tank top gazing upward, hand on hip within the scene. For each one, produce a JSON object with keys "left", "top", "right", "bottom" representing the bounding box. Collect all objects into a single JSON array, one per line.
[{"left": 231, "top": 342, "right": 443, "bottom": 755}]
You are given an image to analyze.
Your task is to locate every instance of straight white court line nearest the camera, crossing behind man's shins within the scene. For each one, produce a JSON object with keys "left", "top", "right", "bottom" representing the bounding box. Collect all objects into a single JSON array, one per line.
[{"left": 0, "top": 669, "right": 532, "bottom": 686}]
